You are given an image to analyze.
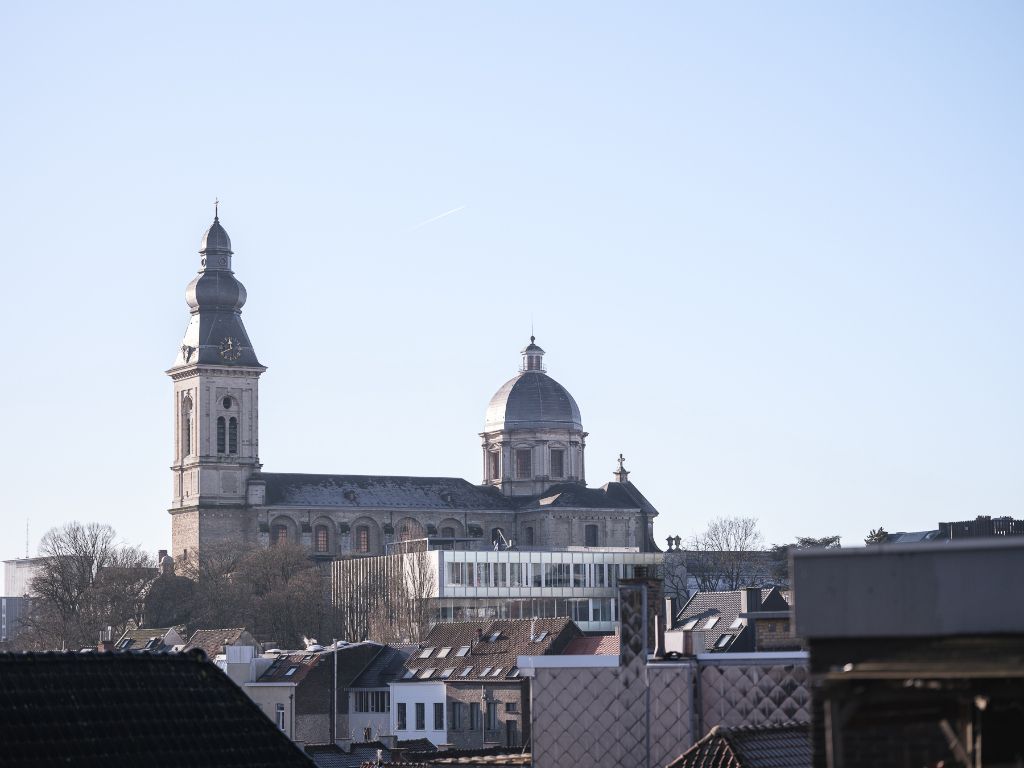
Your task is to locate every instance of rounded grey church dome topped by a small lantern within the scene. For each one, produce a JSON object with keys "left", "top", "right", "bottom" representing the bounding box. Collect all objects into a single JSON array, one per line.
[{"left": 483, "top": 336, "right": 583, "bottom": 432}]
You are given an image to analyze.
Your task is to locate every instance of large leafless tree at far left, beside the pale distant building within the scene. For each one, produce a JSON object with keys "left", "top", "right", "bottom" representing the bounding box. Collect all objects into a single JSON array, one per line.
[{"left": 24, "top": 522, "right": 156, "bottom": 648}]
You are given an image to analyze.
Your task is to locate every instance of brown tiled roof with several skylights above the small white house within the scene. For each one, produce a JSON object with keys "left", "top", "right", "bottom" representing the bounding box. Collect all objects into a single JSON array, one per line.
[{"left": 401, "top": 618, "right": 583, "bottom": 683}]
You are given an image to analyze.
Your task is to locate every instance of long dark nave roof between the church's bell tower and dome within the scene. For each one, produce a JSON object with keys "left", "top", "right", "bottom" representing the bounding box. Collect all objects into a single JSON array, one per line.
[{"left": 260, "top": 472, "right": 512, "bottom": 511}]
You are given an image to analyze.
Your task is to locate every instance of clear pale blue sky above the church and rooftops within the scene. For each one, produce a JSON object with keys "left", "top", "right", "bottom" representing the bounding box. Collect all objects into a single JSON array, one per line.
[{"left": 0, "top": 2, "right": 1024, "bottom": 558}]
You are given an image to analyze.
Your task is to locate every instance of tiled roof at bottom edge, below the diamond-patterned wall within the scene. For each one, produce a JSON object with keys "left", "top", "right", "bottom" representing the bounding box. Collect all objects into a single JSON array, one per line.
[{"left": 668, "top": 723, "right": 811, "bottom": 768}]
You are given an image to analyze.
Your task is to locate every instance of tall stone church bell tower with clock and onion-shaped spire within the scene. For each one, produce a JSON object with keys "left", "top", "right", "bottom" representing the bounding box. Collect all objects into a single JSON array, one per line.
[{"left": 167, "top": 209, "right": 266, "bottom": 557}]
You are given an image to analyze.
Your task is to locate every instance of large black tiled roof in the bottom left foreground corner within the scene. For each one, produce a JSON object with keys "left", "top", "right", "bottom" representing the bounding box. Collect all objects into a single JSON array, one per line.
[{"left": 0, "top": 653, "right": 310, "bottom": 768}]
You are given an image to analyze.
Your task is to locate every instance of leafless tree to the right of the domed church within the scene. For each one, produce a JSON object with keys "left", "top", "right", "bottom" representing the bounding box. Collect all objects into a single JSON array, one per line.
[{"left": 686, "top": 517, "right": 766, "bottom": 592}]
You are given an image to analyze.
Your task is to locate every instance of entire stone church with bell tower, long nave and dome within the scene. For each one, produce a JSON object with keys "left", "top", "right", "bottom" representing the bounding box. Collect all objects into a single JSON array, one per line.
[{"left": 167, "top": 216, "right": 657, "bottom": 559}]
